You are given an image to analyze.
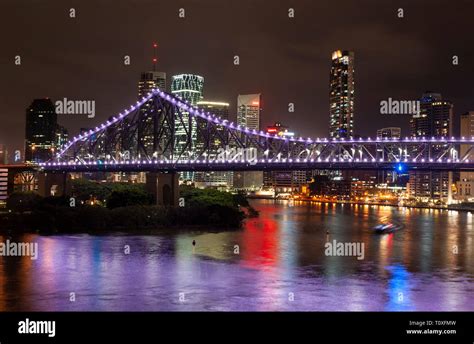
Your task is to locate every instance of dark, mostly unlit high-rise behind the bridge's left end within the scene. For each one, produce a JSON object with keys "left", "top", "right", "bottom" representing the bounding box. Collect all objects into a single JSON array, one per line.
[{"left": 25, "top": 98, "right": 58, "bottom": 162}]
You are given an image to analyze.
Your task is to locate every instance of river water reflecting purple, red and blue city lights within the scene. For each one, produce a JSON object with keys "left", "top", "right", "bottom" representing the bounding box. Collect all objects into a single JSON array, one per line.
[{"left": 0, "top": 200, "right": 474, "bottom": 311}]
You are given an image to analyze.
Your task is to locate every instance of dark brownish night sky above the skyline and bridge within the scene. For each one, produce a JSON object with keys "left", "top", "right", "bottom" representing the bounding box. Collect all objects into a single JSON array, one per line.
[{"left": 0, "top": 0, "right": 474, "bottom": 156}]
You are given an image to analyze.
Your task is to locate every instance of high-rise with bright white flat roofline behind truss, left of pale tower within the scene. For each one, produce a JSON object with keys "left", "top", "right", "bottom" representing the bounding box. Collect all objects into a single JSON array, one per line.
[{"left": 194, "top": 100, "right": 233, "bottom": 188}]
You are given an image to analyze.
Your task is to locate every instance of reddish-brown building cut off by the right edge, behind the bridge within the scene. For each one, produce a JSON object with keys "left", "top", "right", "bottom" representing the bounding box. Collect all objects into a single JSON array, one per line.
[{"left": 456, "top": 111, "right": 474, "bottom": 202}]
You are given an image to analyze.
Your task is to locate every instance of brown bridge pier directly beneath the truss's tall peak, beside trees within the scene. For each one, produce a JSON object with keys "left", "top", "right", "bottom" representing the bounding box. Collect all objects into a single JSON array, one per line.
[{"left": 146, "top": 172, "right": 179, "bottom": 207}]
